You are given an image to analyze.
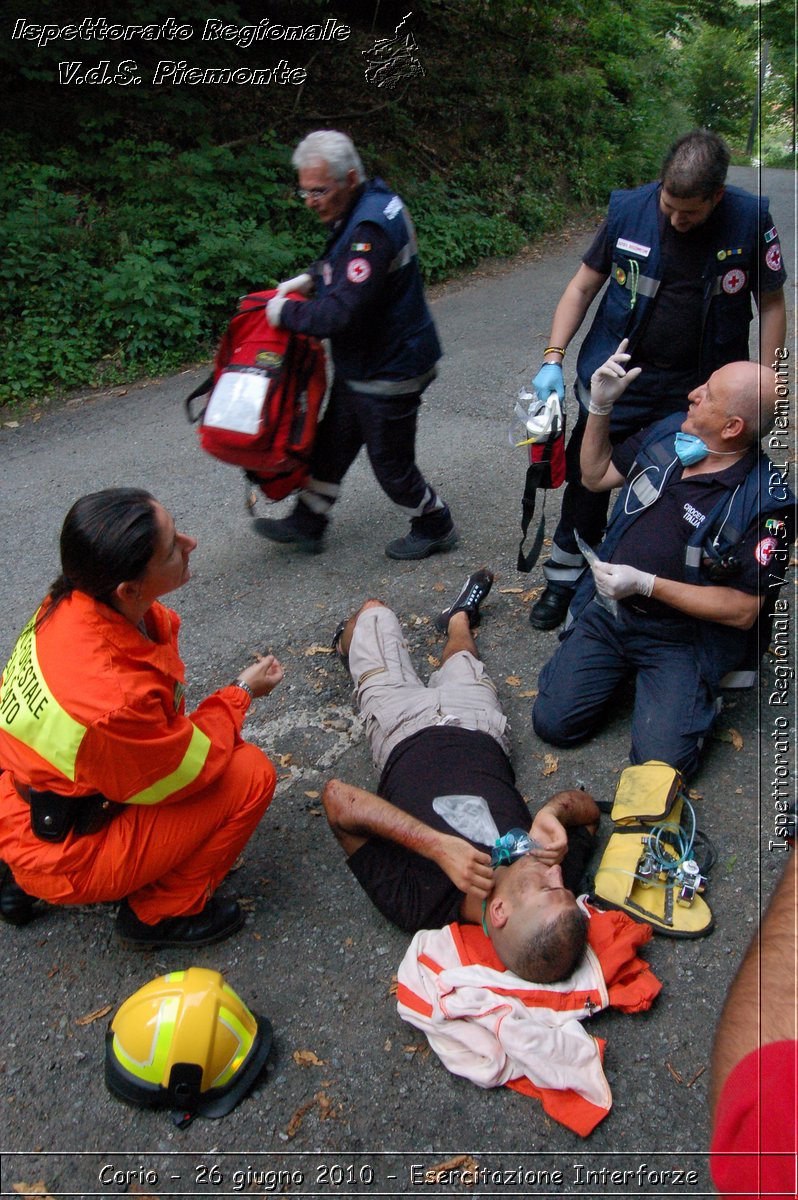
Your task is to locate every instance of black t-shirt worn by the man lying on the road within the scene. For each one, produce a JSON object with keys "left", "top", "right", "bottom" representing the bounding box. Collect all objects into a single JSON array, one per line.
[{"left": 348, "top": 725, "right": 593, "bottom": 932}]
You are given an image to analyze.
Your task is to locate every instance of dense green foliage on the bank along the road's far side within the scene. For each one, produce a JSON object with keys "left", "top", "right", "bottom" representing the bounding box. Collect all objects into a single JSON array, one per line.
[{"left": 0, "top": 0, "right": 793, "bottom": 403}]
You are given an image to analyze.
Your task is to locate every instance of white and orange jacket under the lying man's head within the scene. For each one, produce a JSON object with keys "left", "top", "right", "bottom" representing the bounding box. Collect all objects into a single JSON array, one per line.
[{"left": 396, "top": 900, "right": 661, "bottom": 1136}]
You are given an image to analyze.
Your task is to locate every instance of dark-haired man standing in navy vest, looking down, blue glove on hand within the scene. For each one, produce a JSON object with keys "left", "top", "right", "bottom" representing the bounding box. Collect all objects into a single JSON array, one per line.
[{"left": 529, "top": 130, "right": 786, "bottom": 630}]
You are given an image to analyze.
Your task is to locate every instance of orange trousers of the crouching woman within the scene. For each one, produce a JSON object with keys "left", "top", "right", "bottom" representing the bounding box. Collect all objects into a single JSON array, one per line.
[{"left": 0, "top": 742, "right": 276, "bottom": 925}]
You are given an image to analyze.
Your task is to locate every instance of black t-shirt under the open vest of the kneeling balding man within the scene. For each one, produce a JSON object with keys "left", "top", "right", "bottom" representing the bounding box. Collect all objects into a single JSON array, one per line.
[{"left": 610, "top": 432, "right": 775, "bottom": 622}]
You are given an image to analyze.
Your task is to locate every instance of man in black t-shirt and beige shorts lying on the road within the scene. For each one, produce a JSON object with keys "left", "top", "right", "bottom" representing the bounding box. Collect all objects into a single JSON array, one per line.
[{"left": 324, "top": 571, "right": 599, "bottom": 983}]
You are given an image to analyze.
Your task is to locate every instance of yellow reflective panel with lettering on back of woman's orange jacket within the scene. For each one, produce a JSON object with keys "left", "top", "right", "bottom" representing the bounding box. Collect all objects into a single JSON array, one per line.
[{"left": 0, "top": 617, "right": 86, "bottom": 780}]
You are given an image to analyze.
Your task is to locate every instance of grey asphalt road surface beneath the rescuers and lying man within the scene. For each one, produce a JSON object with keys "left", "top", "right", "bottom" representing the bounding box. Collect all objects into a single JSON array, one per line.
[{"left": 0, "top": 170, "right": 796, "bottom": 1196}]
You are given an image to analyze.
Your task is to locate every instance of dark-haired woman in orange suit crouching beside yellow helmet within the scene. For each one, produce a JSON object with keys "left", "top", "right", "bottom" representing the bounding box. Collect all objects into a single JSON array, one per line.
[{"left": 0, "top": 488, "right": 282, "bottom": 948}]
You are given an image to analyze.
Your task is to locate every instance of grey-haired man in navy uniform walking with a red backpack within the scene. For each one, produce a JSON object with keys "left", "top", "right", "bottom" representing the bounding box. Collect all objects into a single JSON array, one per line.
[{"left": 256, "top": 130, "right": 457, "bottom": 559}]
